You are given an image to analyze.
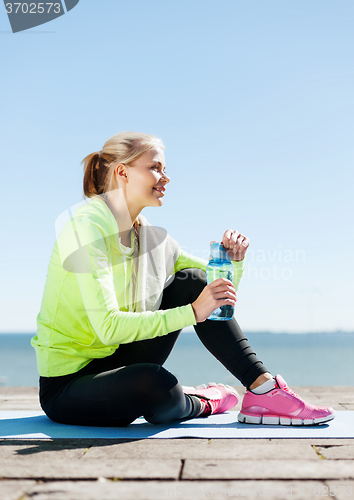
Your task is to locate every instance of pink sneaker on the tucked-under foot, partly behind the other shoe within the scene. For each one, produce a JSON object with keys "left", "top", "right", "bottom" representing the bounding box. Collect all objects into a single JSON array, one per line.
[{"left": 182, "top": 382, "right": 240, "bottom": 415}]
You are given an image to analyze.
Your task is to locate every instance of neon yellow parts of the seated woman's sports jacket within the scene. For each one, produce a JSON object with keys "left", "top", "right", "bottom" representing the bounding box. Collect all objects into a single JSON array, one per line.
[{"left": 31, "top": 199, "right": 244, "bottom": 377}]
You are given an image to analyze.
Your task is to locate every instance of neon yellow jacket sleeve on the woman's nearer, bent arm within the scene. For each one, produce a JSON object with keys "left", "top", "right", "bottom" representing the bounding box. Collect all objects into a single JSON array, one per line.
[{"left": 60, "top": 217, "right": 196, "bottom": 345}]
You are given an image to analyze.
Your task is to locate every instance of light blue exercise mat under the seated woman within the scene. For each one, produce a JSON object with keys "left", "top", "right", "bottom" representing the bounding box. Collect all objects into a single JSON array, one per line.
[{"left": 0, "top": 411, "right": 354, "bottom": 439}]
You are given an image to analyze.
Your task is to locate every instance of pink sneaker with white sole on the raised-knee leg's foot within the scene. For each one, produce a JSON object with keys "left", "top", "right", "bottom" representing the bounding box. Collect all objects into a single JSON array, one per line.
[{"left": 238, "top": 375, "right": 336, "bottom": 425}]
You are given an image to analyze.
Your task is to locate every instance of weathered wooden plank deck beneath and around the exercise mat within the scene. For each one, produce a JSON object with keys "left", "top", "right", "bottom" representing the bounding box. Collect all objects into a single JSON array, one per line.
[{"left": 0, "top": 387, "right": 354, "bottom": 500}]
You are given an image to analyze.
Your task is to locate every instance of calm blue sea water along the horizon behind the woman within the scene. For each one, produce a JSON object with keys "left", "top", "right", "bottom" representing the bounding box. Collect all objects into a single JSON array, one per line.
[{"left": 0, "top": 328, "right": 354, "bottom": 387}]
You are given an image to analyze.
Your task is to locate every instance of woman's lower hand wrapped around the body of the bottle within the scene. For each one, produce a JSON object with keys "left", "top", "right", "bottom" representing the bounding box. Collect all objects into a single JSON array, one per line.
[{"left": 192, "top": 278, "right": 237, "bottom": 323}]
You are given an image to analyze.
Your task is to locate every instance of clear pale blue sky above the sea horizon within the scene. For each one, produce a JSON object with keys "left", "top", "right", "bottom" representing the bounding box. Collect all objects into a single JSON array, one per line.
[{"left": 0, "top": 0, "right": 354, "bottom": 332}]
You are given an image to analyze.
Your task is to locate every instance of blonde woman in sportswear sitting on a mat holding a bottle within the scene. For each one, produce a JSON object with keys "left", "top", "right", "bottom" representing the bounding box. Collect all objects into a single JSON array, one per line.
[{"left": 32, "top": 132, "right": 334, "bottom": 426}]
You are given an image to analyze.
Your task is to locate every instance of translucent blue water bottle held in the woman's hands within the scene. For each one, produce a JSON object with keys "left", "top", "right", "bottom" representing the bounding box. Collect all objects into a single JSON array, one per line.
[{"left": 206, "top": 243, "right": 234, "bottom": 321}]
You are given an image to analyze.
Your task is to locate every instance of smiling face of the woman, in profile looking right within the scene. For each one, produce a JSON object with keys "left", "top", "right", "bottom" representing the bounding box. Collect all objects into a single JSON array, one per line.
[{"left": 125, "top": 149, "right": 170, "bottom": 210}]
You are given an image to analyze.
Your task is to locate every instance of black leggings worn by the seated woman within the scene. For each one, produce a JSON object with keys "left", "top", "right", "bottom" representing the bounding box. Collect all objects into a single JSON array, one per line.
[{"left": 40, "top": 268, "right": 268, "bottom": 427}]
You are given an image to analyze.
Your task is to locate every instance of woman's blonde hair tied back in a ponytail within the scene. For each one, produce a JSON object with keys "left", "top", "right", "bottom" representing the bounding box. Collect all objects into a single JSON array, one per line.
[{"left": 81, "top": 132, "right": 165, "bottom": 202}]
